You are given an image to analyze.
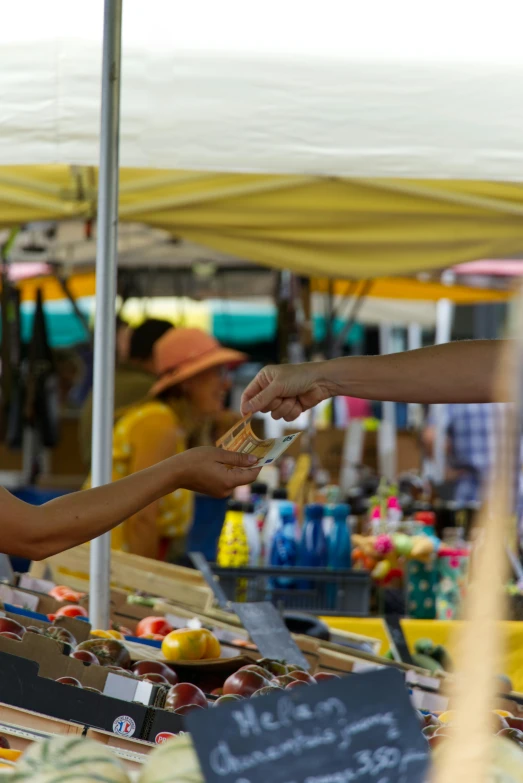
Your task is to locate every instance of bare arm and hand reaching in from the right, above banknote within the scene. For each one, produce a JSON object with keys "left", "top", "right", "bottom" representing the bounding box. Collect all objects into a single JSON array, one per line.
[{"left": 242, "top": 340, "right": 504, "bottom": 421}]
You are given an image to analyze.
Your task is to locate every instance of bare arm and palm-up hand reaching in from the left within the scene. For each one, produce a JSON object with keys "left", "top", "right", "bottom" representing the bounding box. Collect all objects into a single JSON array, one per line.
[{"left": 0, "top": 448, "right": 259, "bottom": 560}]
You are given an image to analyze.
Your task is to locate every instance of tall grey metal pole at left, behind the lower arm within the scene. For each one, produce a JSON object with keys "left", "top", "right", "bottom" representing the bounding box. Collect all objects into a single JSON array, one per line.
[{"left": 89, "top": 0, "right": 122, "bottom": 628}]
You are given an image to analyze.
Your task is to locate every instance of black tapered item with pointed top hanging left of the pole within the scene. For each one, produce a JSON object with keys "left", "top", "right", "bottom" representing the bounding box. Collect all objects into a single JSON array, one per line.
[{"left": 25, "top": 290, "right": 59, "bottom": 448}]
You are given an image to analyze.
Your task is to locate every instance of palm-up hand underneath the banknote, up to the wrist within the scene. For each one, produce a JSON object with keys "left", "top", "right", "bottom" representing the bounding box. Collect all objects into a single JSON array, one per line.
[{"left": 176, "top": 448, "right": 260, "bottom": 498}]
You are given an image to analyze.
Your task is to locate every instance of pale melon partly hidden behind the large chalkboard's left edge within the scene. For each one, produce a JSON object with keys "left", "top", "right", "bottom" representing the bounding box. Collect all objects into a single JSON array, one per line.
[{"left": 139, "top": 734, "right": 204, "bottom": 783}]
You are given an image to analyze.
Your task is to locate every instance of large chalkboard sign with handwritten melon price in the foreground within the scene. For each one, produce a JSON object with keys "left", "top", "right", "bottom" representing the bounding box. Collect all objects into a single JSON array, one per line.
[{"left": 186, "top": 669, "right": 428, "bottom": 783}]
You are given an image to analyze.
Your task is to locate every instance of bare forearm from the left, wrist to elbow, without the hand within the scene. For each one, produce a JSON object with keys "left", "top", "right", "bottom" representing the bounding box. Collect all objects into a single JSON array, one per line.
[{"left": 2, "top": 457, "right": 182, "bottom": 560}]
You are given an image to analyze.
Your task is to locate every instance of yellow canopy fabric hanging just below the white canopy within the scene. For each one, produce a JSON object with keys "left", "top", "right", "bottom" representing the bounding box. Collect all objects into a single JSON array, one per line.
[{"left": 0, "top": 166, "right": 523, "bottom": 279}]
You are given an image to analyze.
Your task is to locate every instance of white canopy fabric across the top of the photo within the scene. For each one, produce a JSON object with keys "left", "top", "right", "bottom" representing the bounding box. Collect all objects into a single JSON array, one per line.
[{"left": 0, "top": 0, "right": 523, "bottom": 181}]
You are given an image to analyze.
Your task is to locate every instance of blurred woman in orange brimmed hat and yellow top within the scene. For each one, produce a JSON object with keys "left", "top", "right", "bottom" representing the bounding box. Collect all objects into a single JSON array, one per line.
[{"left": 86, "top": 329, "right": 246, "bottom": 561}]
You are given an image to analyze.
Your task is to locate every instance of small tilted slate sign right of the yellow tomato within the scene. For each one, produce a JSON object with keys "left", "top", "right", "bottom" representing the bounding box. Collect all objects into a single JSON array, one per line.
[{"left": 232, "top": 601, "right": 310, "bottom": 669}]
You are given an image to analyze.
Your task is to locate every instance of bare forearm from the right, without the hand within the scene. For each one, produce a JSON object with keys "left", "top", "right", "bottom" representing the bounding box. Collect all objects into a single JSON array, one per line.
[{"left": 322, "top": 340, "right": 503, "bottom": 403}]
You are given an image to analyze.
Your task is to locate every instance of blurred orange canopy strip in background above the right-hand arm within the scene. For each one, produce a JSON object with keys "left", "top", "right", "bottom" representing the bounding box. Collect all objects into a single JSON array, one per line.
[{"left": 312, "top": 277, "right": 513, "bottom": 305}]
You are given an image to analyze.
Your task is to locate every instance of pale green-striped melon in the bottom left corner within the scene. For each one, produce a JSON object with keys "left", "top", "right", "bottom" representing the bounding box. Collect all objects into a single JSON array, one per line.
[{"left": 12, "top": 736, "right": 129, "bottom": 783}]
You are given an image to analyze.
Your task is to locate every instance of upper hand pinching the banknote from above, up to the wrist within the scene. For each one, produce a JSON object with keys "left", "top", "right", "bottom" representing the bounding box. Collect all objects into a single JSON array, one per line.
[{"left": 242, "top": 363, "right": 331, "bottom": 421}]
